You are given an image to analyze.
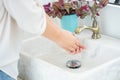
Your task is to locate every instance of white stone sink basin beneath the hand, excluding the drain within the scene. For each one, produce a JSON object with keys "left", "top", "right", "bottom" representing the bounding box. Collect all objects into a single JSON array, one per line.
[{"left": 18, "top": 32, "right": 120, "bottom": 80}]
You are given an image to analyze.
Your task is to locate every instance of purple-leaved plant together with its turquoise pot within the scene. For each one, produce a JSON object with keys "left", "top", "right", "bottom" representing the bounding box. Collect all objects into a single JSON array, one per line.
[{"left": 43, "top": 0, "right": 108, "bottom": 32}]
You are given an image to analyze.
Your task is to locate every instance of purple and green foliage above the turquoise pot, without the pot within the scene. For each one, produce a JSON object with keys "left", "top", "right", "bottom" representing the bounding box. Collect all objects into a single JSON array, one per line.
[{"left": 43, "top": 0, "right": 108, "bottom": 19}]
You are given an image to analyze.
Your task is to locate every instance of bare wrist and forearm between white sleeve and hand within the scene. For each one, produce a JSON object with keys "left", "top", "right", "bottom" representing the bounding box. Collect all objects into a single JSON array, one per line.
[{"left": 43, "top": 15, "right": 63, "bottom": 42}]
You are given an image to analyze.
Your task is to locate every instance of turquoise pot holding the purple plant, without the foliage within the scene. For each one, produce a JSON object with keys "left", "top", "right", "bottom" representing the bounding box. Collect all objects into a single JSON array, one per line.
[{"left": 61, "top": 14, "right": 78, "bottom": 32}]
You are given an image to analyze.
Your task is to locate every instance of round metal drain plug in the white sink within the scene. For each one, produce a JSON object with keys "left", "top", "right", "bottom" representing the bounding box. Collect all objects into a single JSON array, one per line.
[{"left": 66, "top": 60, "right": 81, "bottom": 69}]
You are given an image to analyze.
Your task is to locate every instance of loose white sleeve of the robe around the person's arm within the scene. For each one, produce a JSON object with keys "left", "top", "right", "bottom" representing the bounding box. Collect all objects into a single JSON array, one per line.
[{"left": 3, "top": 0, "right": 46, "bottom": 34}]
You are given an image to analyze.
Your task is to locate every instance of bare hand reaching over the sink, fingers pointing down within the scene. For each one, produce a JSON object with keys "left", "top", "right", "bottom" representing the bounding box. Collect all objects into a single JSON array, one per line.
[{"left": 56, "top": 30, "right": 85, "bottom": 54}]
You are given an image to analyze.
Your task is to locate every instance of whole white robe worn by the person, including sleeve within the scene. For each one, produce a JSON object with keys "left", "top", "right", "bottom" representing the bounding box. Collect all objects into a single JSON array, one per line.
[{"left": 0, "top": 0, "right": 46, "bottom": 67}]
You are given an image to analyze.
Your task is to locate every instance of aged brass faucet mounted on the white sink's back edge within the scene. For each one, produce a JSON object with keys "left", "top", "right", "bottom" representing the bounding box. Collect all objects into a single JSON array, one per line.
[{"left": 75, "top": 17, "right": 101, "bottom": 39}]
